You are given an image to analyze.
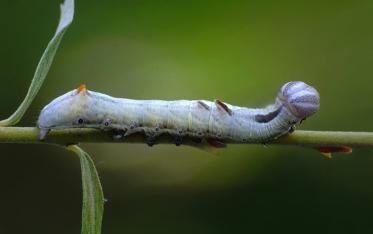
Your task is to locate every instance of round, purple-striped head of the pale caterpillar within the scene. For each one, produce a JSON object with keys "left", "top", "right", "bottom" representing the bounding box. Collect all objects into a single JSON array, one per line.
[{"left": 276, "top": 81, "right": 320, "bottom": 120}]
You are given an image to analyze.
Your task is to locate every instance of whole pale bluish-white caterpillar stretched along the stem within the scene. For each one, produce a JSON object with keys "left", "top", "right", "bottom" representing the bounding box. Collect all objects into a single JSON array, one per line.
[{"left": 37, "top": 81, "right": 320, "bottom": 147}]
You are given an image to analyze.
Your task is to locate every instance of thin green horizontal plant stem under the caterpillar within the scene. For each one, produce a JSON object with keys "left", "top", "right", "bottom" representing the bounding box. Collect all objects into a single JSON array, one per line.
[{"left": 0, "top": 127, "right": 373, "bottom": 148}]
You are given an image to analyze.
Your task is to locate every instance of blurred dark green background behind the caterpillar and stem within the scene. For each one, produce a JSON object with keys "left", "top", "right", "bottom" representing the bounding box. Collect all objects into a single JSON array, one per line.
[{"left": 0, "top": 0, "right": 373, "bottom": 234}]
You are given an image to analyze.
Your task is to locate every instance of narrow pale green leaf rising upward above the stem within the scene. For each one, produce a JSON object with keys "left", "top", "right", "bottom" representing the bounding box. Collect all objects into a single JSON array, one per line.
[{"left": 0, "top": 0, "right": 74, "bottom": 126}]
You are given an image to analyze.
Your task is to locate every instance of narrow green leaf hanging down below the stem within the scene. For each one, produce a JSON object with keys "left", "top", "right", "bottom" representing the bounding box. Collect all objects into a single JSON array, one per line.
[{"left": 67, "top": 145, "right": 104, "bottom": 234}]
